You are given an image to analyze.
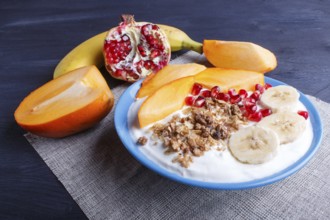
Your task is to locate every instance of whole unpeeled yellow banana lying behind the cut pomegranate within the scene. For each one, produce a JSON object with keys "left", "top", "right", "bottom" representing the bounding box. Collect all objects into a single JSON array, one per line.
[{"left": 53, "top": 25, "right": 203, "bottom": 78}]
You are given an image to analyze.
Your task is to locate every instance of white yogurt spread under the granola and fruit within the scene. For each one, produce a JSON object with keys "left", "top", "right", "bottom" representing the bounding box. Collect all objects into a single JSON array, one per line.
[{"left": 128, "top": 99, "right": 313, "bottom": 183}]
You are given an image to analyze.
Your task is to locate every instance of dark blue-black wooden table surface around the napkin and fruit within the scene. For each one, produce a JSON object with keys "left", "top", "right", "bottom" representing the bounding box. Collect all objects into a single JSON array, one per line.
[{"left": 0, "top": 0, "right": 330, "bottom": 219}]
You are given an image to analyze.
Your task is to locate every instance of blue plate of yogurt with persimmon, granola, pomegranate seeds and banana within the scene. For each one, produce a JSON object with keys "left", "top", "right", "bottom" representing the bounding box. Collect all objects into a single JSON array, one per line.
[{"left": 115, "top": 64, "right": 322, "bottom": 189}]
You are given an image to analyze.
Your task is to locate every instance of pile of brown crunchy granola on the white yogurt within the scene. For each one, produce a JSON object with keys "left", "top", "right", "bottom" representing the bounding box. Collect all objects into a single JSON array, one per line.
[{"left": 139, "top": 97, "right": 247, "bottom": 168}]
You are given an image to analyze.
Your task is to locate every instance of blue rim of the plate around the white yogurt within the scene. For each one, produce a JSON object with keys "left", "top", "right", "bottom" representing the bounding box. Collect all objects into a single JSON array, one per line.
[{"left": 115, "top": 77, "right": 322, "bottom": 190}]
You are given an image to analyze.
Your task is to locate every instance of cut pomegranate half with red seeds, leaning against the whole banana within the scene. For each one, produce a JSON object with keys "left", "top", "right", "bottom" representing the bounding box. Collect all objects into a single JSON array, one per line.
[{"left": 103, "top": 15, "right": 171, "bottom": 82}]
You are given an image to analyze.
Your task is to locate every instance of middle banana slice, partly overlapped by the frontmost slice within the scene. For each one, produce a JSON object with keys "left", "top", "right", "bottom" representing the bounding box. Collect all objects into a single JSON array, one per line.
[{"left": 257, "top": 112, "right": 307, "bottom": 144}]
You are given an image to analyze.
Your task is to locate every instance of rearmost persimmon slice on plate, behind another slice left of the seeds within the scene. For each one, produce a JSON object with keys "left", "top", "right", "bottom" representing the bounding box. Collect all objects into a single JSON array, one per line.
[{"left": 136, "top": 63, "right": 206, "bottom": 98}]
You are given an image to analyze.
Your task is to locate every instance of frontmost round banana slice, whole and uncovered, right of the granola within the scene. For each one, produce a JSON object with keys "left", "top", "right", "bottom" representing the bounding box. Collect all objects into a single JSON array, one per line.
[{"left": 228, "top": 126, "right": 280, "bottom": 164}]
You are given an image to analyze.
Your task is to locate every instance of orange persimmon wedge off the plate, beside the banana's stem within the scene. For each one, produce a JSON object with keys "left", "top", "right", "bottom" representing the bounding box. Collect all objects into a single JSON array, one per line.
[{"left": 203, "top": 40, "right": 277, "bottom": 73}]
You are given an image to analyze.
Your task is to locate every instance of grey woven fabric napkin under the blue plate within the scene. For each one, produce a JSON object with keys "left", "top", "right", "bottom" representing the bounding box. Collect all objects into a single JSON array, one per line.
[{"left": 26, "top": 52, "right": 330, "bottom": 219}]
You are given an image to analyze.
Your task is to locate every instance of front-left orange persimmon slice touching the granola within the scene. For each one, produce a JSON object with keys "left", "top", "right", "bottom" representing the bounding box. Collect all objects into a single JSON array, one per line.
[{"left": 138, "top": 76, "right": 194, "bottom": 128}]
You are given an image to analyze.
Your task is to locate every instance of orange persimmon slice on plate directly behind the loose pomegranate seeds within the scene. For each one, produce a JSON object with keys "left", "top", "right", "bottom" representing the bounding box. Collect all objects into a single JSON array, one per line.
[{"left": 195, "top": 68, "right": 265, "bottom": 92}]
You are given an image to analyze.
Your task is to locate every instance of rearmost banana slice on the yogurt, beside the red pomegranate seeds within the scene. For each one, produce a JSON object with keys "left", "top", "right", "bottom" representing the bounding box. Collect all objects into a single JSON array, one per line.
[{"left": 260, "top": 85, "right": 300, "bottom": 112}]
